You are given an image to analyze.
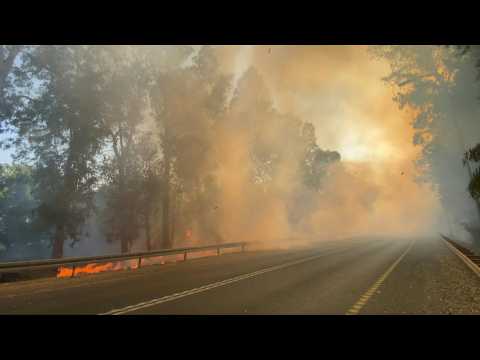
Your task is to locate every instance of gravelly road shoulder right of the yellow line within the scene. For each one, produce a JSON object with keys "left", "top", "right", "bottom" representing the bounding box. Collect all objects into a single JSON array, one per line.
[{"left": 361, "top": 238, "right": 480, "bottom": 314}]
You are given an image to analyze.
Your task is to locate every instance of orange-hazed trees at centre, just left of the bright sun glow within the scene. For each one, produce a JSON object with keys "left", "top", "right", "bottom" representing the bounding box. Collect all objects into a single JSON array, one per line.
[{"left": 210, "top": 67, "right": 339, "bottom": 240}]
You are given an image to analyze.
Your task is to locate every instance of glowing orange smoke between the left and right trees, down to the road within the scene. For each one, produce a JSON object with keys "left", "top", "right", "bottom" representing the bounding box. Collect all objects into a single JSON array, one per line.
[{"left": 210, "top": 46, "right": 439, "bottom": 246}]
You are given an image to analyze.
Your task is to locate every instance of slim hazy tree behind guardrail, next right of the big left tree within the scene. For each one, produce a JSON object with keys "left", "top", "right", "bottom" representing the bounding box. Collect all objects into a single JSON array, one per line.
[{"left": 89, "top": 46, "right": 151, "bottom": 253}]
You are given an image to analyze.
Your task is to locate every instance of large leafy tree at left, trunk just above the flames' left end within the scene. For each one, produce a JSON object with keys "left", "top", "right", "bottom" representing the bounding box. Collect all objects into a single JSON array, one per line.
[{"left": 8, "top": 46, "right": 103, "bottom": 258}]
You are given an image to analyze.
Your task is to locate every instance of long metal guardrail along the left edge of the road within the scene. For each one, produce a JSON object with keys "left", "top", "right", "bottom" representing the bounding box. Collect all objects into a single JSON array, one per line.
[{"left": 0, "top": 242, "right": 247, "bottom": 273}]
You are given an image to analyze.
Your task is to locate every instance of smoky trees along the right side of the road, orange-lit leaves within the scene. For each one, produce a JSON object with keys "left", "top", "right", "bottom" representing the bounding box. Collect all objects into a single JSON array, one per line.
[{"left": 370, "top": 45, "right": 480, "bottom": 249}]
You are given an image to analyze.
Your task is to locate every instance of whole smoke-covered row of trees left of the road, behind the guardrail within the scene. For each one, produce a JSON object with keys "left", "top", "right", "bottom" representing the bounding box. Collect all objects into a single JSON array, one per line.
[{"left": 0, "top": 45, "right": 340, "bottom": 258}]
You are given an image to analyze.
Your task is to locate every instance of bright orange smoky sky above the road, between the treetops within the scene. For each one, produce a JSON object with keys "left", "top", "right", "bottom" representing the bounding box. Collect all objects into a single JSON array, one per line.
[{"left": 216, "top": 46, "right": 416, "bottom": 165}]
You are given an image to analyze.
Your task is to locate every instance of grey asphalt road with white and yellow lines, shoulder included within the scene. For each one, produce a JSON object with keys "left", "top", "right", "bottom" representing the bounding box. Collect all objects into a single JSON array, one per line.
[{"left": 0, "top": 238, "right": 480, "bottom": 315}]
